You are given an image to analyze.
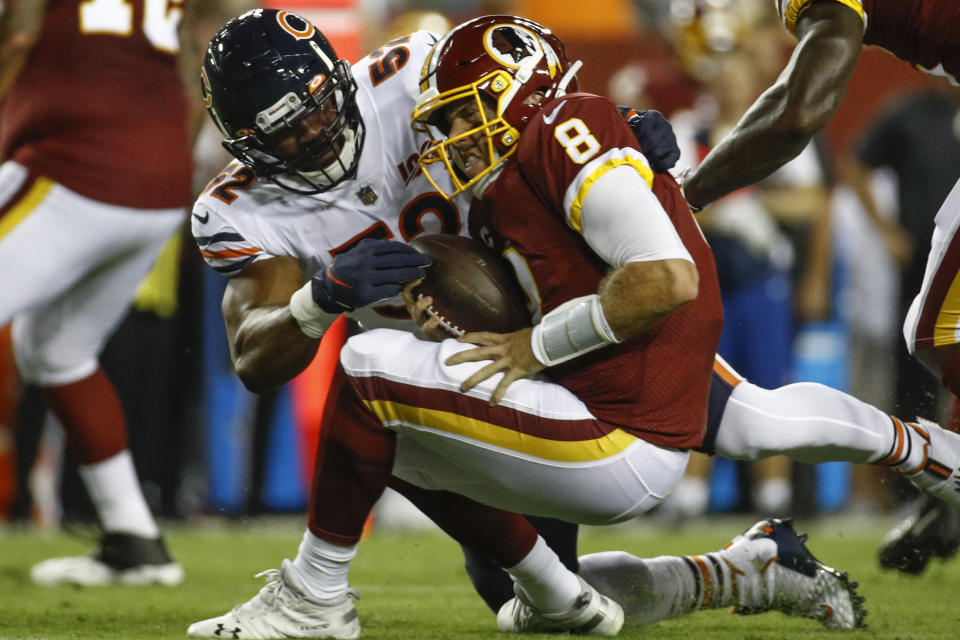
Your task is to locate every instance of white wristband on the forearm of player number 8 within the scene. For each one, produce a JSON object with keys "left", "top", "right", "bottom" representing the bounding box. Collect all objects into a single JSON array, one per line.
[{"left": 530, "top": 293, "right": 620, "bottom": 367}]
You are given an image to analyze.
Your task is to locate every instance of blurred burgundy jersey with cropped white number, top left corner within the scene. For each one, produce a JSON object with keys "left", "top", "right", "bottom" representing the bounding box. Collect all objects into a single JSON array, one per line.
[{"left": 0, "top": 0, "right": 193, "bottom": 209}]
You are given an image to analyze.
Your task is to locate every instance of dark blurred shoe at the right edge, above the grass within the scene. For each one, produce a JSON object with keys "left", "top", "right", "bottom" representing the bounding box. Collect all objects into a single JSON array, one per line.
[{"left": 877, "top": 495, "right": 960, "bottom": 574}]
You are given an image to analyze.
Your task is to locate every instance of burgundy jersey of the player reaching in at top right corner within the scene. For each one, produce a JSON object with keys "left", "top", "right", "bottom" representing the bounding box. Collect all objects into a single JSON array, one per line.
[{"left": 776, "top": 0, "right": 960, "bottom": 82}]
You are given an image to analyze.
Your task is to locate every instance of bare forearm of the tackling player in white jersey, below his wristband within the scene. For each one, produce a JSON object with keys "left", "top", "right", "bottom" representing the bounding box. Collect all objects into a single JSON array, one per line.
[{"left": 230, "top": 306, "right": 320, "bottom": 392}]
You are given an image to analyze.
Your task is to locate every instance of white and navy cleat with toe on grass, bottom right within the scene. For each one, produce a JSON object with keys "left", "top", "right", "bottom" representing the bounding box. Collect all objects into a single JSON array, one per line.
[{"left": 722, "top": 518, "right": 867, "bottom": 631}]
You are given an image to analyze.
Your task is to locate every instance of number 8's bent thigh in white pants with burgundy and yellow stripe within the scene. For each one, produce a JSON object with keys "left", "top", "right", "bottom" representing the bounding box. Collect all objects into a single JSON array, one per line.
[{"left": 341, "top": 330, "right": 689, "bottom": 524}]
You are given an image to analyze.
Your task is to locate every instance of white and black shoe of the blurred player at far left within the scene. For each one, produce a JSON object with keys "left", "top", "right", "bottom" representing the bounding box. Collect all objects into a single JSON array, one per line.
[{"left": 30, "top": 533, "right": 183, "bottom": 586}]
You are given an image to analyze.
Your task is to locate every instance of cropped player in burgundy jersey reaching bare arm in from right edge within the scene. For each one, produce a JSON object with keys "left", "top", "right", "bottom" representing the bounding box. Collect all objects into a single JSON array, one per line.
[{"left": 684, "top": 0, "right": 960, "bottom": 573}]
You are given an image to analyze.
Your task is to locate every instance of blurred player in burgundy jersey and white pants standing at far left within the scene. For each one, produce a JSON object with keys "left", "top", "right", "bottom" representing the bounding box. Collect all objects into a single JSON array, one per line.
[{"left": 0, "top": 0, "right": 210, "bottom": 585}]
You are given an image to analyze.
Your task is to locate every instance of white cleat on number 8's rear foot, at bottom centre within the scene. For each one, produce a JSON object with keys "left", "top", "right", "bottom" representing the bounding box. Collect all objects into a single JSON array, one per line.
[{"left": 497, "top": 576, "right": 623, "bottom": 636}]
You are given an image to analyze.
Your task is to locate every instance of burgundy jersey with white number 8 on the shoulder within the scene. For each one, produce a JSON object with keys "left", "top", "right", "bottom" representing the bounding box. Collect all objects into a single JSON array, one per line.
[{"left": 471, "top": 94, "right": 723, "bottom": 447}]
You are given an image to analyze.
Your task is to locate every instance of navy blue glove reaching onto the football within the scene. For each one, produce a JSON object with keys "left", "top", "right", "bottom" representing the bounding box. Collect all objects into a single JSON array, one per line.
[{"left": 310, "top": 238, "right": 430, "bottom": 313}]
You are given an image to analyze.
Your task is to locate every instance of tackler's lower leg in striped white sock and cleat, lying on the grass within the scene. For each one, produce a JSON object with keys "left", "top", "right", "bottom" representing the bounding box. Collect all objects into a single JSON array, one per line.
[{"left": 580, "top": 519, "right": 866, "bottom": 630}]
